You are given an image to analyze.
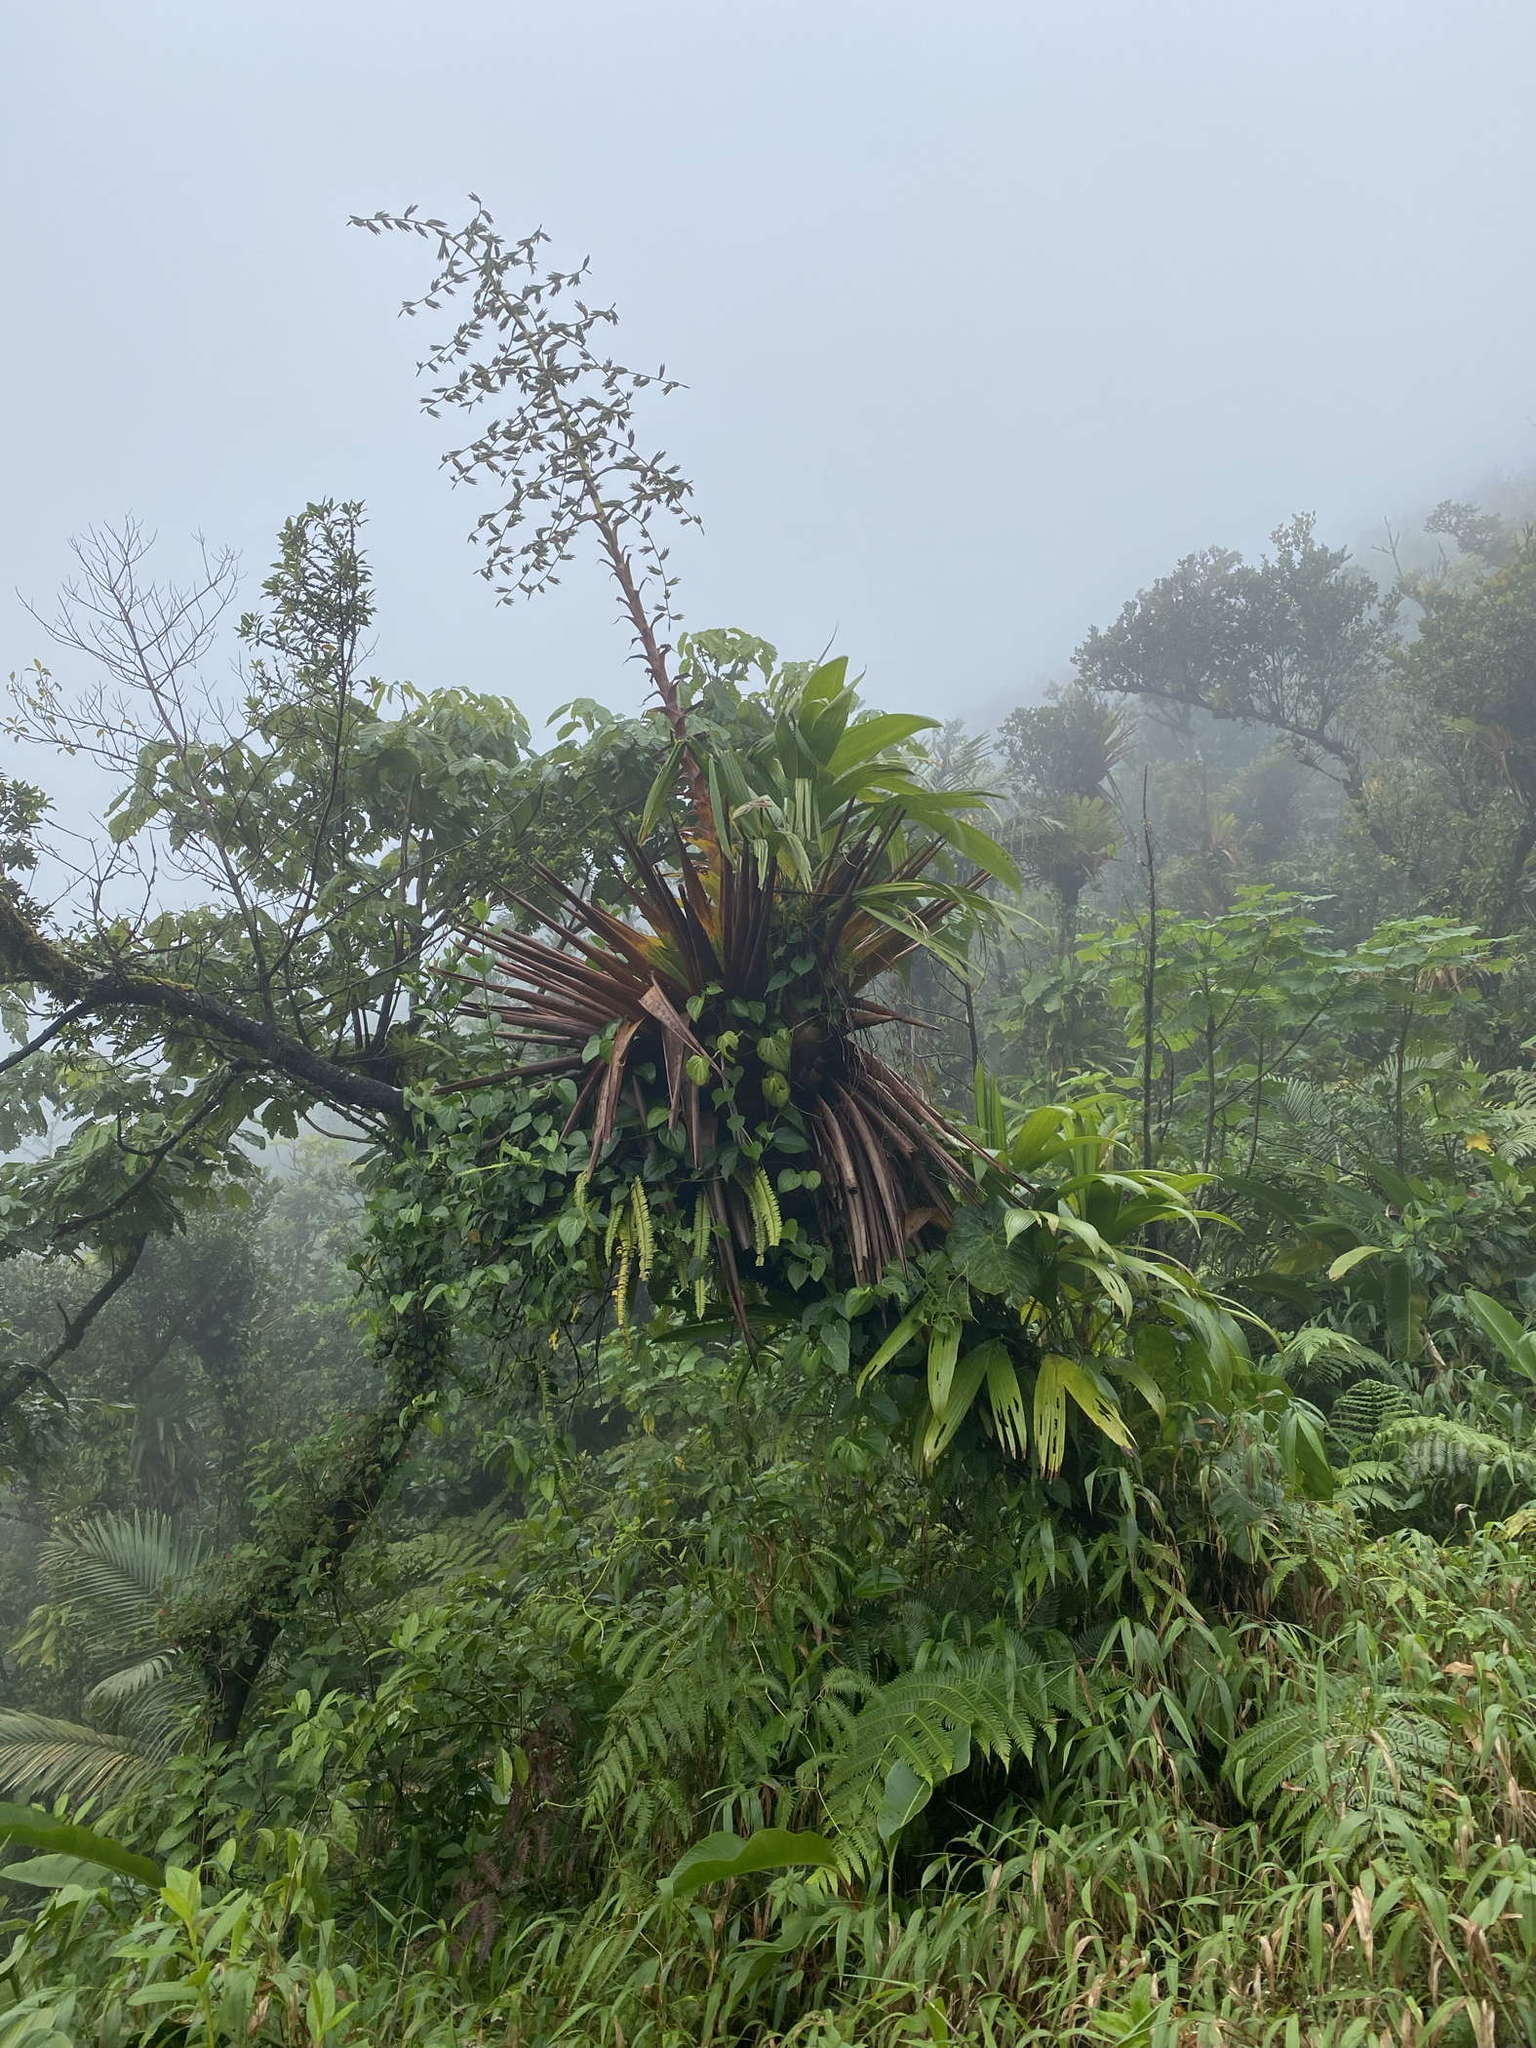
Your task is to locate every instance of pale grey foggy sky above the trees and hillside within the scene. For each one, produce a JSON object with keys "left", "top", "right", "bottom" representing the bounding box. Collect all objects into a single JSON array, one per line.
[{"left": 0, "top": 0, "right": 1536, "bottom": 772}]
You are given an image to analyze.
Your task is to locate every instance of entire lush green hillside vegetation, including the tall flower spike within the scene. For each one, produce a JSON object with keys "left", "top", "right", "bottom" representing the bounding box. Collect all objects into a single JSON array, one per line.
[{"left": 0, "top": 211, "right": 1536, "bottom": 2048}]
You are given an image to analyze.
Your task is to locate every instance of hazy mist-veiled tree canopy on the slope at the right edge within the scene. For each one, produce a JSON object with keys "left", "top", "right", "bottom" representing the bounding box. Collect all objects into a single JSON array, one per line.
[{"left": 1077, "top": 502, "right": 1536, "bottom": 934}]
